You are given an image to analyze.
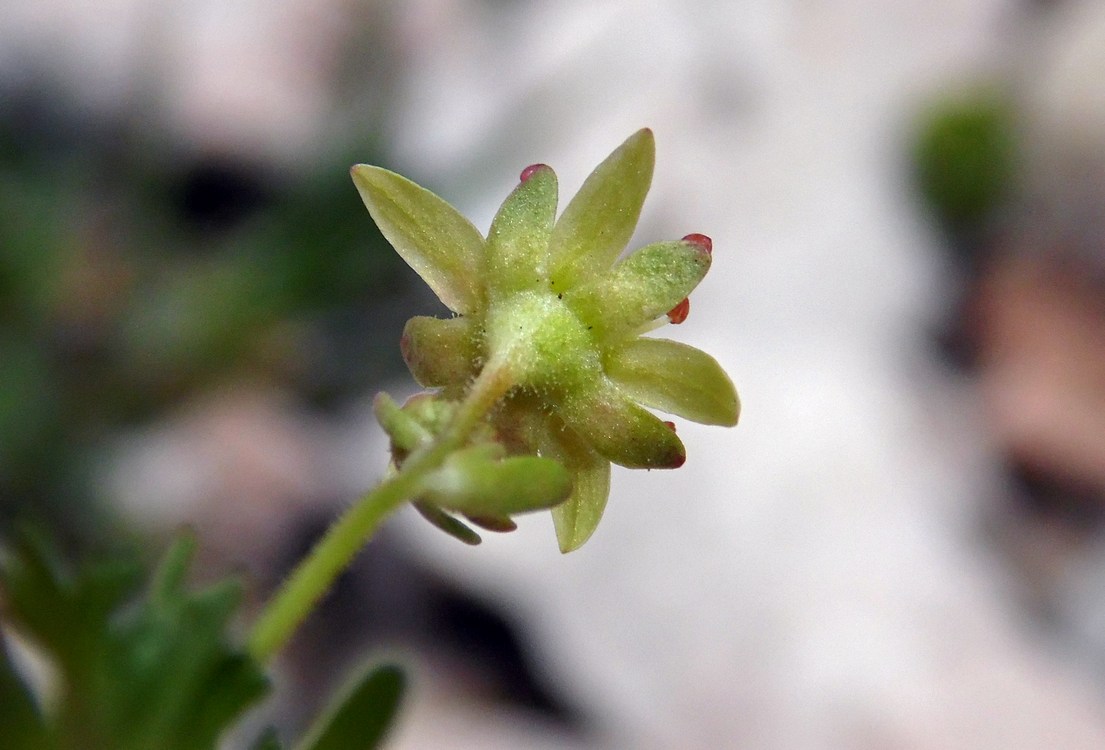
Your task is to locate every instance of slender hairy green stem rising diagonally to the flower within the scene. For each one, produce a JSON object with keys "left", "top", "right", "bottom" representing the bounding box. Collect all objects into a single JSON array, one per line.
[{"left": 248, "top": 367, "right": 512, "bottom": 664}]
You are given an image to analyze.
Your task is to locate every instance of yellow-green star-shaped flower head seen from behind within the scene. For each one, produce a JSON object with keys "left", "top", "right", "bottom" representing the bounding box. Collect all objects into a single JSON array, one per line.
[{"left": 352, "top": 129, "right": 739, "bottom": 551}]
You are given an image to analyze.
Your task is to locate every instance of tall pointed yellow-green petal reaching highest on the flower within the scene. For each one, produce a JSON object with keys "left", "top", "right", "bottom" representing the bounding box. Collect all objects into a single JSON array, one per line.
[{"left": 549, "top": 128, "right": 656, "bottom": 292}]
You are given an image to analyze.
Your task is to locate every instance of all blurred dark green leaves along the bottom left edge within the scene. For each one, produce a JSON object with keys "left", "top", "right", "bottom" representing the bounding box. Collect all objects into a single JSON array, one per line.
[{"left": 0, "top": 534, "right": 404, "bottom": 750}]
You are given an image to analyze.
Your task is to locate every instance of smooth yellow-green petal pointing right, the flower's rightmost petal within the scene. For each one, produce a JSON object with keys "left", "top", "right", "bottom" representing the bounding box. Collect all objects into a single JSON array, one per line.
[{"left": 603, "top": 338, "right": 740, "bottom": 427}]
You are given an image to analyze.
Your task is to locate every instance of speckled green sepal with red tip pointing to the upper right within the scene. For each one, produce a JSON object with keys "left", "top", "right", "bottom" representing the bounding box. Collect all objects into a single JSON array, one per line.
[{"left": 565, "top": 240, "right": 711, "bottom": 337}]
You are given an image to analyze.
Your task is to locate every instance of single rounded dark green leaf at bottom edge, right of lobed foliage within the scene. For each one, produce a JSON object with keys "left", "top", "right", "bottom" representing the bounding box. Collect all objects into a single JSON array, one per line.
[{"left": 297, "top": 665, "right": 407, "bottom": 750}]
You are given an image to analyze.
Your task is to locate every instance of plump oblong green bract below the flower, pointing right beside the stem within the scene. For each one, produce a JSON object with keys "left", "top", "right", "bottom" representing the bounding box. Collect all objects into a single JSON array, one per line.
[{"left": 422, "top": 445, "right": 571, "bottom": 517}]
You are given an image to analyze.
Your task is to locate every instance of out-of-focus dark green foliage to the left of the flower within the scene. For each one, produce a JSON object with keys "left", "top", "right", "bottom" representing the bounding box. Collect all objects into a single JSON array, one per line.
[{"left": 0, "top": 89, "right": 415, "bottom": 541}]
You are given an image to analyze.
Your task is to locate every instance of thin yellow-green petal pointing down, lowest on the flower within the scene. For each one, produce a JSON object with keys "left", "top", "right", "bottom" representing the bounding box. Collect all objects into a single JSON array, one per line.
[{"left": 544, "top": 419, "right": 610, "bottom": 553}]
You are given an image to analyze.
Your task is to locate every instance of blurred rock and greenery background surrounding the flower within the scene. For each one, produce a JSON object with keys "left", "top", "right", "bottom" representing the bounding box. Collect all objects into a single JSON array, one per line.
[{"left": 0, "top": 0, "right": 1105, "bottom": 750}]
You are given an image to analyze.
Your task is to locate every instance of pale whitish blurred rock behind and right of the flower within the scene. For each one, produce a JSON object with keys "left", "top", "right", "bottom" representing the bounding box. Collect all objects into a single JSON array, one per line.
[{"left": 8, "top": 0, "right": 1105, "bottom": 750}]
